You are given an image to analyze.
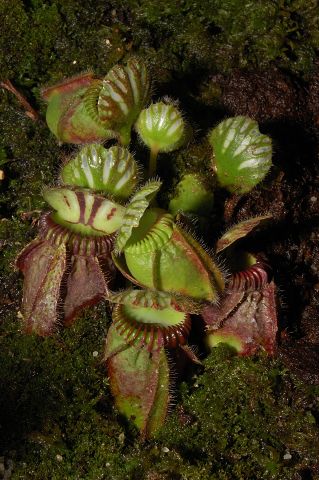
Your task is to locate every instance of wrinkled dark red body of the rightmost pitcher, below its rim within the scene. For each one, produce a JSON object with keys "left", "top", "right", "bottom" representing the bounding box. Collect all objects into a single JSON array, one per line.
[{"left": 203, "top": 282, "right": 277, "bottom": 355}]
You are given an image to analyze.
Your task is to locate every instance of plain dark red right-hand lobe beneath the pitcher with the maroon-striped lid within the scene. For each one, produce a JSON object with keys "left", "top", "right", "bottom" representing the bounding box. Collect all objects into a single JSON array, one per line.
[{"left": 64, "top": 255, "right": 108, "bottom": 325}]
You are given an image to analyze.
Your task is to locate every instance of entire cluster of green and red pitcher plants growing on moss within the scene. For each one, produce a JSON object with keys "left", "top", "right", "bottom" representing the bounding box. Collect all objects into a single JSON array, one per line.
[{"left": 16, "top": 57, "right": 277, "bottom": 437}]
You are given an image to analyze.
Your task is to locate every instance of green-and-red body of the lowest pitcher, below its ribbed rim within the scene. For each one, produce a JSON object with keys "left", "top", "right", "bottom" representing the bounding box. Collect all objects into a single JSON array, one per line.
[{"left": 105, "top": 325, "right": 169, "bottom": 438}]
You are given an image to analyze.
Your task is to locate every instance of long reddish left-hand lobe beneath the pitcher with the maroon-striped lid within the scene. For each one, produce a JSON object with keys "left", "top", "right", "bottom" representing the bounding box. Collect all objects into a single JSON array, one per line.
[{"left": 16, "top": 240, "right": 66, "bottom": 336}]
